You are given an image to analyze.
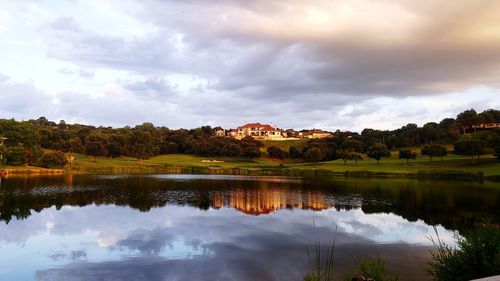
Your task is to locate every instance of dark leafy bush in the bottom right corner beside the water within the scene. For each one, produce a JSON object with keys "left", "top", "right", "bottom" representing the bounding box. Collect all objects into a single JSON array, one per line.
[{"left": 428, "top": 227, "right": 500, "bottom": 281}]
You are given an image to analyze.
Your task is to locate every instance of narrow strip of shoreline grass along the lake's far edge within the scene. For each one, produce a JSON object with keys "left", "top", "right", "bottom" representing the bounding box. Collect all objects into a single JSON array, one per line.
[{"left": 0, "top": 165, "right": 500, "bottom": 182}]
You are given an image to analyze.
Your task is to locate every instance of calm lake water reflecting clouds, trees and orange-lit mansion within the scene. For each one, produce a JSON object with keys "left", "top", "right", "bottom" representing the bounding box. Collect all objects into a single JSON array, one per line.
[{"left": 0, "top": 175, "right": 500, "bottom": 280}]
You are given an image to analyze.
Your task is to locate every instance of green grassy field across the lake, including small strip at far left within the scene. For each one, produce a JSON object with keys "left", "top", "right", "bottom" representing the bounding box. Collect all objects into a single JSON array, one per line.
[{"left": 0, "top": 150, "right": 500, "bottom": 176}]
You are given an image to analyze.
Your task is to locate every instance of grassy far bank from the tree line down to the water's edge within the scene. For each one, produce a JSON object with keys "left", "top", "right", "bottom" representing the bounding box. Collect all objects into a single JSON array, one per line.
[{"left": 0, "top": 154, "right": 500, "bottom": 181}]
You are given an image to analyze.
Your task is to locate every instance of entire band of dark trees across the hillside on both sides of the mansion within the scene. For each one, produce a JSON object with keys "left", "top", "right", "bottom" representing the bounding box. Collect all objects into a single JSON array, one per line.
[{"left": 0, "top": 109, "right": 500, "bottom": 167}]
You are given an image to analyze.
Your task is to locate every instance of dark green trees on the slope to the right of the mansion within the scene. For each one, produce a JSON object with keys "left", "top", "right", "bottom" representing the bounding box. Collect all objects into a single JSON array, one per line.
[{"left": 267, "top": 109, "right": 500, "bottom": 164}]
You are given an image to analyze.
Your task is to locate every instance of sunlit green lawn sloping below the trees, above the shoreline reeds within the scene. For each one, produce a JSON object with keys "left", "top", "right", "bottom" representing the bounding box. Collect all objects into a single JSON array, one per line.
[{"left": 66, "top": 153, "right": 500, "bottom": 176}]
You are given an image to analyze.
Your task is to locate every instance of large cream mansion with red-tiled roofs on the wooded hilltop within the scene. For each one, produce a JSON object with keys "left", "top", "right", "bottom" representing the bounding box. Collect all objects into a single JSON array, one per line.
[{"left": 214, "top": 123, "right": 333, "bottom": 140}]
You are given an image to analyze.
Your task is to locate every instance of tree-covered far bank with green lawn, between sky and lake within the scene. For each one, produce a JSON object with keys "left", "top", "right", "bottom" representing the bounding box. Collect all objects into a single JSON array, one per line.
[{"left": 0, "top": 109, "right": 500, "bottom": 176}]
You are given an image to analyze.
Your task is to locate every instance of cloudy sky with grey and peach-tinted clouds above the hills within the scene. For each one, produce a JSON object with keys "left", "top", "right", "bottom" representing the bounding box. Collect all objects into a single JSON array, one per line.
[{"left": 0, "top": 0, "right": 500, "bottom": 131}]
